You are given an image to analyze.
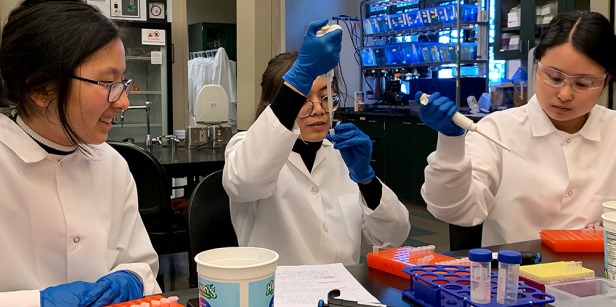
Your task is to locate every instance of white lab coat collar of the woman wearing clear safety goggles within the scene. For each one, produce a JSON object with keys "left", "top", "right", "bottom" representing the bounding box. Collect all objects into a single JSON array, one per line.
[{"left": 527, "top": 95, "right": 605, "bottom": 141}]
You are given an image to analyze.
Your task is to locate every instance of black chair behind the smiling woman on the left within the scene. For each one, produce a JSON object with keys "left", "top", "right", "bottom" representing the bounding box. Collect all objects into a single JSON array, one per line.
[{"left": 107, "top": 141, "right": 189, "bottom": 291}]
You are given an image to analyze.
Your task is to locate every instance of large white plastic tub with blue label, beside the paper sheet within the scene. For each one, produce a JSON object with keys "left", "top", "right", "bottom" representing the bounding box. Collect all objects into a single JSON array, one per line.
[{"left": 195, "top": 247, "right": 278, "bottom": 307}]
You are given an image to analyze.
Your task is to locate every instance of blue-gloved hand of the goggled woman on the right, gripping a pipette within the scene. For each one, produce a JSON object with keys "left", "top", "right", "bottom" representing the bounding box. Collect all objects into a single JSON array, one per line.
[{"left": 415, "top": 92, "right": 465, "bottom": 136}]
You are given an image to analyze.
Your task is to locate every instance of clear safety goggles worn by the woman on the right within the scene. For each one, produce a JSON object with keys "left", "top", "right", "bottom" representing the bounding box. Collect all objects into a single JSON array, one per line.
[{"left": 537, "top": 63, "right": 607, "bottom": 92}]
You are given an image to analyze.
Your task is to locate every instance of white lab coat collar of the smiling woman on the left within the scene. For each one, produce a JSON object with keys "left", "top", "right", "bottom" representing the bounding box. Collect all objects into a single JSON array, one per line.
[{"left": 0, "top": 115, "right": 100, "bottom": 163}]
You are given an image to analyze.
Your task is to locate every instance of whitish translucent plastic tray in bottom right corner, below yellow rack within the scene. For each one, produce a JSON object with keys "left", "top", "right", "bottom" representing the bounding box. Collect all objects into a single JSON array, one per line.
[{"left": 546, "top": 278, "right": 616, "bottom": 307}]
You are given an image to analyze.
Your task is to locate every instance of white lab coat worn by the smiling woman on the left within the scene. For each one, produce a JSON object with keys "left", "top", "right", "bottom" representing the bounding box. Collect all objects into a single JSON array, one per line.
[{"left": 0, "top": 115, "right": 161, "bottom": 306}]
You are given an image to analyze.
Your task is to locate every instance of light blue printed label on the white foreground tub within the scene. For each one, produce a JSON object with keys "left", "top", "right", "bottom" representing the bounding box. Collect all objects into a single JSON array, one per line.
[{"left": 199, "top": 275, "right": 274, "bottom": 307}]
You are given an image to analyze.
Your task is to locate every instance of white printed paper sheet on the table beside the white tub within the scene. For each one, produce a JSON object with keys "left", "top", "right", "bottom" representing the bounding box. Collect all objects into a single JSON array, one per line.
[{"left": 274, "top": 263, "right": 379, "bottom": 307}]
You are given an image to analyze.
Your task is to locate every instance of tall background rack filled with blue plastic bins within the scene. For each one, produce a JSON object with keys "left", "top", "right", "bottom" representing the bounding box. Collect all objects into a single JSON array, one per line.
[{"left": 359, "top": 0, "right": 490, "bottom": 109}]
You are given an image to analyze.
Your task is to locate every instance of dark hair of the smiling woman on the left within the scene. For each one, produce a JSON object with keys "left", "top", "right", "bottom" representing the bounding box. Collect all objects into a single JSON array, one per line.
[{"left": 0, "top": 0, "right": 120, "bottom": 149}]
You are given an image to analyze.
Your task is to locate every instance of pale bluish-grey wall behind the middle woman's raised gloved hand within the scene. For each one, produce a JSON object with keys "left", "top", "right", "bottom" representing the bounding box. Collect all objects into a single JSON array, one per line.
[{"left": 285, "top": 0, "right": 361, "bottom": 107}]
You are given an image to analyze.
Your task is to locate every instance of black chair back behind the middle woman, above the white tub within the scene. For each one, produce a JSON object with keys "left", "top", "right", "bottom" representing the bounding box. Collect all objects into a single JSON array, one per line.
[{"left": 188, "top": 170, "right": 238, "bottom": 288}]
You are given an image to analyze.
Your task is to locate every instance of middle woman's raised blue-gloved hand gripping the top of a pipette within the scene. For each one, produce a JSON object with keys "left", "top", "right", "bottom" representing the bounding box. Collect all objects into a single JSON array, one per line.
[{"left": 282, "top": 19, "right": 342, "bottom": 95}]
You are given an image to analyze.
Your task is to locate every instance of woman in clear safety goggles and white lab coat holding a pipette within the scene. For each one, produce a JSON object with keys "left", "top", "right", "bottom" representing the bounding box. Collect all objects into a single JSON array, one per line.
[{"left": 418, "top": 11, "right": 616, "bottom": 246}]
